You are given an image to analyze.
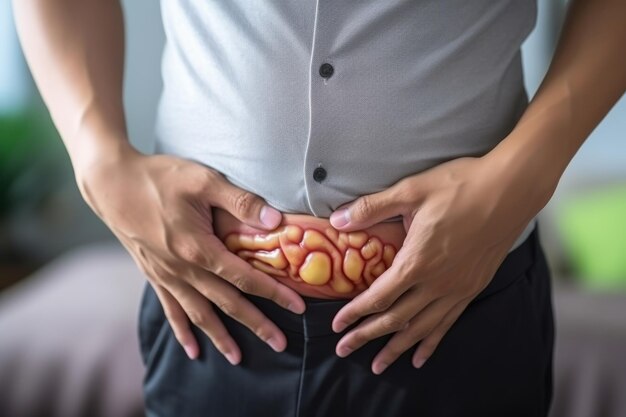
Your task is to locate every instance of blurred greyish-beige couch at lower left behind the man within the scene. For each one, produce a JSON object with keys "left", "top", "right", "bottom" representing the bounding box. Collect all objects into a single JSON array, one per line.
[{"left": 0, "top": 243, "right": 145, "bottom": 417}]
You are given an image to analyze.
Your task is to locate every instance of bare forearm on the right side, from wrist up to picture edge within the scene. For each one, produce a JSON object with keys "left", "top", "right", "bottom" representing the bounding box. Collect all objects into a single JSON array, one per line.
[{"left": 486, "top": 0, "right": 626, "bottom": 211}]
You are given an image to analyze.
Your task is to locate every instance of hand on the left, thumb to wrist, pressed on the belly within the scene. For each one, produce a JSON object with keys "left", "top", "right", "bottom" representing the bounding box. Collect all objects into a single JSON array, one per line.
[{"left": 76, "top": 147, "right": 305, "bottom": 365}]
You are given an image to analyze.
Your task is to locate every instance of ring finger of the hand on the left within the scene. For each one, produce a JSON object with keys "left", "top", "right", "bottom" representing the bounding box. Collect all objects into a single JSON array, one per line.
[{"left": 163, "top": 281, "right": 241, "bottom": 365}]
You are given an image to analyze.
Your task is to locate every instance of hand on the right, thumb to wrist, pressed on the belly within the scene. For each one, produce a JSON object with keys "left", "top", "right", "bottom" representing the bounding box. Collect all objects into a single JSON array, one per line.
[{"left": 331, "top": 157, "right": 545, "bottom": 374}]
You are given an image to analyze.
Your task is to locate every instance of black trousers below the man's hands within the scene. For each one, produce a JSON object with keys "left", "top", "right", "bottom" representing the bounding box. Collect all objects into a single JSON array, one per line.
[{"left": 140, "top": 223, "right": 554, "bottom": 417}]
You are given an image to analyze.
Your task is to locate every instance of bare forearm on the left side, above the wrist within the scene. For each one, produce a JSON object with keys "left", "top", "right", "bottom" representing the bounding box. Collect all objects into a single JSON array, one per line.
[{"left": 13, "top": 0, "right": 130, "bottom": 176}]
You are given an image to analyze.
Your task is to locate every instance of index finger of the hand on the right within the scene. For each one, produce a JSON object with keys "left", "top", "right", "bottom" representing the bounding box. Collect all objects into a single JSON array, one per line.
[{"left": 332, "top": 254, "right": 415, "bottom": 333}]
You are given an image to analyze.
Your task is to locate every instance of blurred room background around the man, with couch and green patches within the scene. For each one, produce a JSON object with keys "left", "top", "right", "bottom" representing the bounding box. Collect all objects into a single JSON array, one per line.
[{"left": 0, "top": 0, "right": 626, "bottom": 417}]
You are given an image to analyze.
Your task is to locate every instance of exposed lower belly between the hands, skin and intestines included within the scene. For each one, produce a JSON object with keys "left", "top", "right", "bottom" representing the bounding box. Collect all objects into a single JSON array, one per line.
[{"left": 213, "top": 207, "right": 406, "bottom": 298}]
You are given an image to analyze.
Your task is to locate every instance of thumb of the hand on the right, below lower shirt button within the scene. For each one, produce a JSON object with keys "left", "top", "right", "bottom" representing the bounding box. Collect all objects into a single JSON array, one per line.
[{"left": 329, "top": 187, "right": 402, "bottom": 231}]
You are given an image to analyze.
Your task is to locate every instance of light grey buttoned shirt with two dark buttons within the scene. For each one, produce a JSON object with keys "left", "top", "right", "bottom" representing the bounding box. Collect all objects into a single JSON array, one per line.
[{"left": 155, "top": 0, "right": 536, "bottom": 250}]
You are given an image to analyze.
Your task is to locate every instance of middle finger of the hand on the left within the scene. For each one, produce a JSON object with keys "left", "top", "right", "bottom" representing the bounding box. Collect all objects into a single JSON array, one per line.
[{"left": 186, "top": 270, "right": 287, "bottom": 352}]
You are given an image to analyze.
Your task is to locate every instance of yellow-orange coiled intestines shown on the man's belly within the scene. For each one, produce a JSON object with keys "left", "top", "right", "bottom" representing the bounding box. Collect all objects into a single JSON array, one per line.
[{"left": 224, "top": 225, "right": 397, "bottom": 293}]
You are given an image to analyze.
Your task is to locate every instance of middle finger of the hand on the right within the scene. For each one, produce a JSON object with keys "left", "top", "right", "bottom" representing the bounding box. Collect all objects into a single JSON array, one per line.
[{"left": 336, "top": 291, "right": 434, "bottom": 357}]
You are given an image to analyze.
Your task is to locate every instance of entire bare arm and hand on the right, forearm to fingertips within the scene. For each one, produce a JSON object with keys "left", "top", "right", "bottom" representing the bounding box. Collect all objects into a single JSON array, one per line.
[{"left": 330, "top": 0, "right": 626, "bottom": 374}]
